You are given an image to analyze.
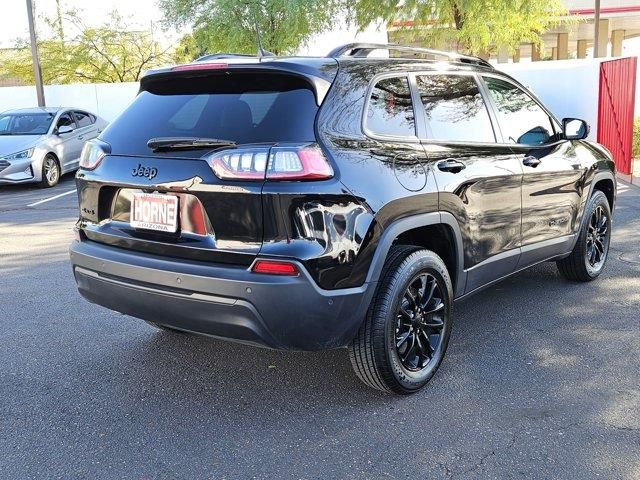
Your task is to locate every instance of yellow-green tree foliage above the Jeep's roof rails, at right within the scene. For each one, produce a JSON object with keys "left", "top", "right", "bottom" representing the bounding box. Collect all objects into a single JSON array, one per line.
[{"left": 354, "top": 0, "right": 573, "bottom": 54}]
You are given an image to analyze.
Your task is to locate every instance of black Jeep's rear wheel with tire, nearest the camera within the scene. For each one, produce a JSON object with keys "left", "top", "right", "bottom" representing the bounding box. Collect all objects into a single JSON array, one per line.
[{"left": 349, "top": 246, "right": 453, "bottom": 395}]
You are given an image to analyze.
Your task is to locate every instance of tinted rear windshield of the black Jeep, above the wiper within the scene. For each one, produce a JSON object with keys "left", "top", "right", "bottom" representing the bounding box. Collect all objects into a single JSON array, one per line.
[{"left": 102, "top": 73, "right": 318, "bottom": 156}]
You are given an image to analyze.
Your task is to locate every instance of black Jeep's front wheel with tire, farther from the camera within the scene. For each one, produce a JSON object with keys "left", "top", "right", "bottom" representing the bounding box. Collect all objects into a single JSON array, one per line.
[{"left": 556, "top": 190, "right": 611, "bottom": 282}]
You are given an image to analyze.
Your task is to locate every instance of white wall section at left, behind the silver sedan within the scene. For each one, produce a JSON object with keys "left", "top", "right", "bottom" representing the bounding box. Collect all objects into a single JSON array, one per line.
[{"left": 0, "top": 82, "right": 139, "bottom": 122}]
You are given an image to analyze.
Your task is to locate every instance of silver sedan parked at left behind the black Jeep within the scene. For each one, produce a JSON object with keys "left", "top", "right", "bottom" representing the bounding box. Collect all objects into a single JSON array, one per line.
[{"left": 0, "top": 107, "right": 107, "bottom": 187}]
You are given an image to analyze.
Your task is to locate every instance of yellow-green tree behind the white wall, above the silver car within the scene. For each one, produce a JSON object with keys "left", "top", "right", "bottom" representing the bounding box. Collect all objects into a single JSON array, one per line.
[{"left": 1, "top": 11, "right": 172, "bottom": 84}]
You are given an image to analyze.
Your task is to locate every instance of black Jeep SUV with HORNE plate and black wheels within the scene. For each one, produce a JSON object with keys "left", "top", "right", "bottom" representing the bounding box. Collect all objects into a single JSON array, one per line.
[{"left": 71, "top": 44, "right": 616, "bottom": 394}]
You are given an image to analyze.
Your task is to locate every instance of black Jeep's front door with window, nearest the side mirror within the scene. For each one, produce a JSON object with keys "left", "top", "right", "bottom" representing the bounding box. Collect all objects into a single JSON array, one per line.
[{"left": 482, "top": 75, "right": 585, "bottom": 267}]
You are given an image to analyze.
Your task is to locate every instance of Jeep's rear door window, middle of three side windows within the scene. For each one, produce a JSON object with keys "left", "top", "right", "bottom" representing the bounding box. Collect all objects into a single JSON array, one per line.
[{"left": 417, "top": 75, "right": 496, "bottom": 143}]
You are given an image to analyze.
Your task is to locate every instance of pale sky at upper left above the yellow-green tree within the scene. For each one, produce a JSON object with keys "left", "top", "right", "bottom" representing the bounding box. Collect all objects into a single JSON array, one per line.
[{"left": 0, "top": 0, "right": 176, "bottom": 48}]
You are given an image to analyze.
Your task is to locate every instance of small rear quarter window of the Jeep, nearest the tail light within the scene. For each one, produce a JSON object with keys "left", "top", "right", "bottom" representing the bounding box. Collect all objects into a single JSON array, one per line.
[{"left": 366, "top": 77, "right": 416, "bottom": 137}]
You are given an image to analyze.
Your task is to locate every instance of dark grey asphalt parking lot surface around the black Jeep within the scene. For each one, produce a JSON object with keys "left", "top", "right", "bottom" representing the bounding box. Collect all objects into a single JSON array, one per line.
[{"left": 0, "top": 176, "right": 640, "bottom": 479}]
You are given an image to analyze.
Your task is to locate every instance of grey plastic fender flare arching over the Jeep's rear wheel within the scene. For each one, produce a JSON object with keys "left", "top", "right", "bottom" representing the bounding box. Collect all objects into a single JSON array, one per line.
[{"left": 366, "top": 212, "right": 466, "bottom": 297}]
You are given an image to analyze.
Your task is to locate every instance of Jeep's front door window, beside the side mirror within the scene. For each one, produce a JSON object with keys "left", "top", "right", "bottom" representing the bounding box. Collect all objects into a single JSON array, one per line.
[{"left": 483, "top": 77, "right": 555, "bottom": 145}]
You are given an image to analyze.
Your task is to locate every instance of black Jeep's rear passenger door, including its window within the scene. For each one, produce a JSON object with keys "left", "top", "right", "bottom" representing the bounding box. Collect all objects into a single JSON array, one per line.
[{"left": 415, "top": 72, "right": 522, "bottom": 292}]
